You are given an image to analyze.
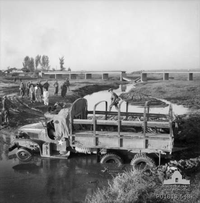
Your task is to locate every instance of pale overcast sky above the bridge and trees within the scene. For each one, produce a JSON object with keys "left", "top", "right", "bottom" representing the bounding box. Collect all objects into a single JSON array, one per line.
[{"left": 0, "top": 0, "right": 200, "bottom": 72}]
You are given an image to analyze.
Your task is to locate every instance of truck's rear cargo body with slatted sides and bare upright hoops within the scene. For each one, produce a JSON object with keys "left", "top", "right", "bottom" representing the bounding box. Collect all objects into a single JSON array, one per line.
[{"left": 69, "top": 99, "right": 177, "bottom": 168}]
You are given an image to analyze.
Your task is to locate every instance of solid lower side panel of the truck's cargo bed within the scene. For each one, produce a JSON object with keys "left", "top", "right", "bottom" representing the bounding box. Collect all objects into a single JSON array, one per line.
[{"left": 71, "top": 130, "right": 171, "bottom": 151}]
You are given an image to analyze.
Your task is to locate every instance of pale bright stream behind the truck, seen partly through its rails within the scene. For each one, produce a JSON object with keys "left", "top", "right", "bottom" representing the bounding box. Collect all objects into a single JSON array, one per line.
[{"left": 84, "top": 84, "right": 189, "bottom": 115}]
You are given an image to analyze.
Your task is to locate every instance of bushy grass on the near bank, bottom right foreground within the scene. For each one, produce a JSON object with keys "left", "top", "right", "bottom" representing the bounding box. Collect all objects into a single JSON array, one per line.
[{"left": 85, "top": 167, "right": 200, "bottom": 203}]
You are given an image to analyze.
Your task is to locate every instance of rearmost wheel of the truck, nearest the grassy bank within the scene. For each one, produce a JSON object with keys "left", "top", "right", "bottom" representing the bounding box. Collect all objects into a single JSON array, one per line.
[{"left": 131, "top": 154, "right": 155, "bottom": 170}]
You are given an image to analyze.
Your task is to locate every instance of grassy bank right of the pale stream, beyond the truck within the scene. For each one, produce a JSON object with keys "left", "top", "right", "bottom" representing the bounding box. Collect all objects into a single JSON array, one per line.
[{"left": 119, "top": 80, "right": 200, "bottom": 110}]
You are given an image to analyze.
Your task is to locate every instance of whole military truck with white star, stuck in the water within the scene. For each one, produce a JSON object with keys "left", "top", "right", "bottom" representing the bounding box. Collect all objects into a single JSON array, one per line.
[{"left": 10, "top": 98, "right": 182, "bottom": 168}]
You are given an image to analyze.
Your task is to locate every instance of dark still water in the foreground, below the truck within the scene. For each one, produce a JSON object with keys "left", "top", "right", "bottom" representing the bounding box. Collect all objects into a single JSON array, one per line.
[{"left": 0, "top": 132, "right": 111, "bottom": 203}]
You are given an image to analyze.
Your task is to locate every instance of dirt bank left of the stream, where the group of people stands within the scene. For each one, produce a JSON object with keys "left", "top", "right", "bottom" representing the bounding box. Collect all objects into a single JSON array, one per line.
[{"left": 0, "top": 80, "right": 120, "bottom": 130}]
